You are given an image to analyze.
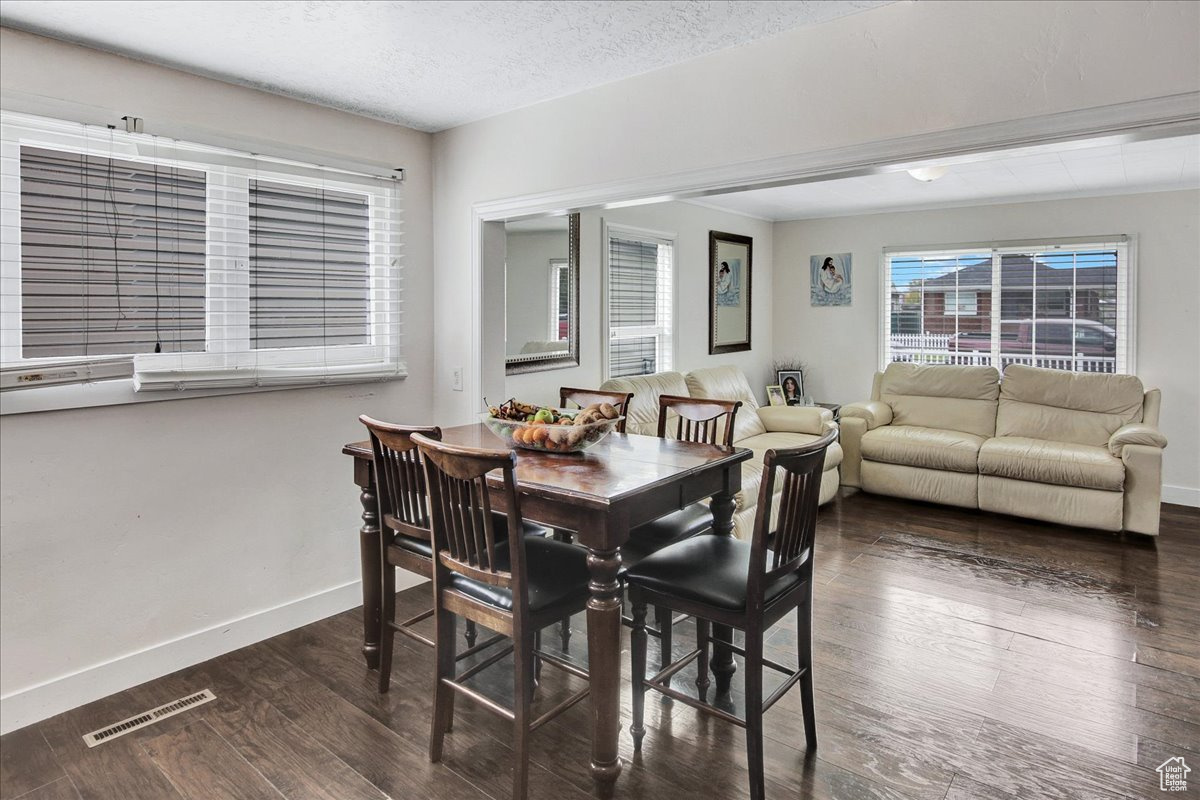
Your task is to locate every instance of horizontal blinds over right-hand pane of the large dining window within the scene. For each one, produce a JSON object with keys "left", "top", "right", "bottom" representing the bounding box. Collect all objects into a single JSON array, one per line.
[{"left": 250, "top": 180, "right": 371, "bottom": 350}]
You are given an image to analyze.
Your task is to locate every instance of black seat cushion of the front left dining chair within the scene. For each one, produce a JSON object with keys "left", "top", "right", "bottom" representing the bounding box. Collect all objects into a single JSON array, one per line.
[{"left": 450, "top": 536, "right": 588, "bottom": 612}]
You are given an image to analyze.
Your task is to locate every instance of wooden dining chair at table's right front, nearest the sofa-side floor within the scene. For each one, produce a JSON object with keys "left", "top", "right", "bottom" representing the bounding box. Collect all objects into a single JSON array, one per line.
[{"left": 625, "top": 431, "right": 838, "bottom": 800}]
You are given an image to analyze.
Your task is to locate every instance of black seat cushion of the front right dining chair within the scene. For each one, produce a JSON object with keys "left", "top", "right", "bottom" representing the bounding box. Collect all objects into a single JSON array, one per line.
[{"left": 625, "top": 536, "right": 810, "bottom": 610}]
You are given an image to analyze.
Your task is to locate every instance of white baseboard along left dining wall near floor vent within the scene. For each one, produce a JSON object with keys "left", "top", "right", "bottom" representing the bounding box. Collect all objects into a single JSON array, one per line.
[{"left": 0, "top": 573, "right": 420, "bottom": 734}]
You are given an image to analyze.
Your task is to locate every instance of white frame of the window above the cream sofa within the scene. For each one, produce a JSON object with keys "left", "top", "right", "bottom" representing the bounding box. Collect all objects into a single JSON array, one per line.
[{"left": 876, "top": 234, "right": 1138, "bottom": 374}]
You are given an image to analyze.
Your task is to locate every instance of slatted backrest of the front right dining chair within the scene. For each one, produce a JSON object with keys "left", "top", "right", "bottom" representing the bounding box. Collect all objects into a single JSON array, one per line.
[{"left": 746, "top": 431, "right": 838, "bottom": 604}]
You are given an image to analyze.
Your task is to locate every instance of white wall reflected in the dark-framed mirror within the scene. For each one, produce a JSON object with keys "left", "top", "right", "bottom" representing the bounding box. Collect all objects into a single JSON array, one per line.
[{"left": 504, "top": 227, "right": 570, "bottom": 355}]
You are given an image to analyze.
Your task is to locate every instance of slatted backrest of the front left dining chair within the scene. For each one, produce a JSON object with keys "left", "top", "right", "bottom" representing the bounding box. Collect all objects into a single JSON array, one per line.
[{"left": 413, "top": 434, "right": 524, "bottom": 603}]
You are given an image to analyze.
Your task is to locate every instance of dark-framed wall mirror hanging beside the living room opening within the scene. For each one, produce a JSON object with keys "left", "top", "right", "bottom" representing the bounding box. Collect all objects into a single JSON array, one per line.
[{"left": 504, "top": 213, "right": 580, "bottom": 375}]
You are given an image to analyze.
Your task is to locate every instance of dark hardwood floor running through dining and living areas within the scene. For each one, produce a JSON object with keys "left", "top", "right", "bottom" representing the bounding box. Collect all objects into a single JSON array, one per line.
[{"left": 0, "top": 494, "right": 1200, "bottom": 800}]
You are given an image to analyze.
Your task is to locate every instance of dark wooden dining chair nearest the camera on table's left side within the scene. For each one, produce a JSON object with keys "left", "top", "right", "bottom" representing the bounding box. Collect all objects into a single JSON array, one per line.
[{"left": 413, "top": 434, "right": 589, "bottom": 800}]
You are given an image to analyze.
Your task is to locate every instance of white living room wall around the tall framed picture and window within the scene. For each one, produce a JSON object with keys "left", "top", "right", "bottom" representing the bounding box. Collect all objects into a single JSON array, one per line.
[{"left": 504, "top": 203, "right": 773, "bottom": 405}]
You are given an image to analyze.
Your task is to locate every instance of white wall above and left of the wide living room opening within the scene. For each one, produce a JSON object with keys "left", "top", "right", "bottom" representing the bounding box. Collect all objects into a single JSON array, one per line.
[{"left": 434, "top": 0, "right": 1200, "bottom": 422}]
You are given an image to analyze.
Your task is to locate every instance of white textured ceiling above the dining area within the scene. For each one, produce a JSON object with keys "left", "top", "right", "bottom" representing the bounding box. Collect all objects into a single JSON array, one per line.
[{"left": 0, "top": 0, "right": 890, "bottom": 131}]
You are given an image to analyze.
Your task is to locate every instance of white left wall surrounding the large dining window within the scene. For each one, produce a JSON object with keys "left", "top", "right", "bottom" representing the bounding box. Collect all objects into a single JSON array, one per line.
[{"left": 0, "top": 29, "right": 433, "bottom": 730}]
